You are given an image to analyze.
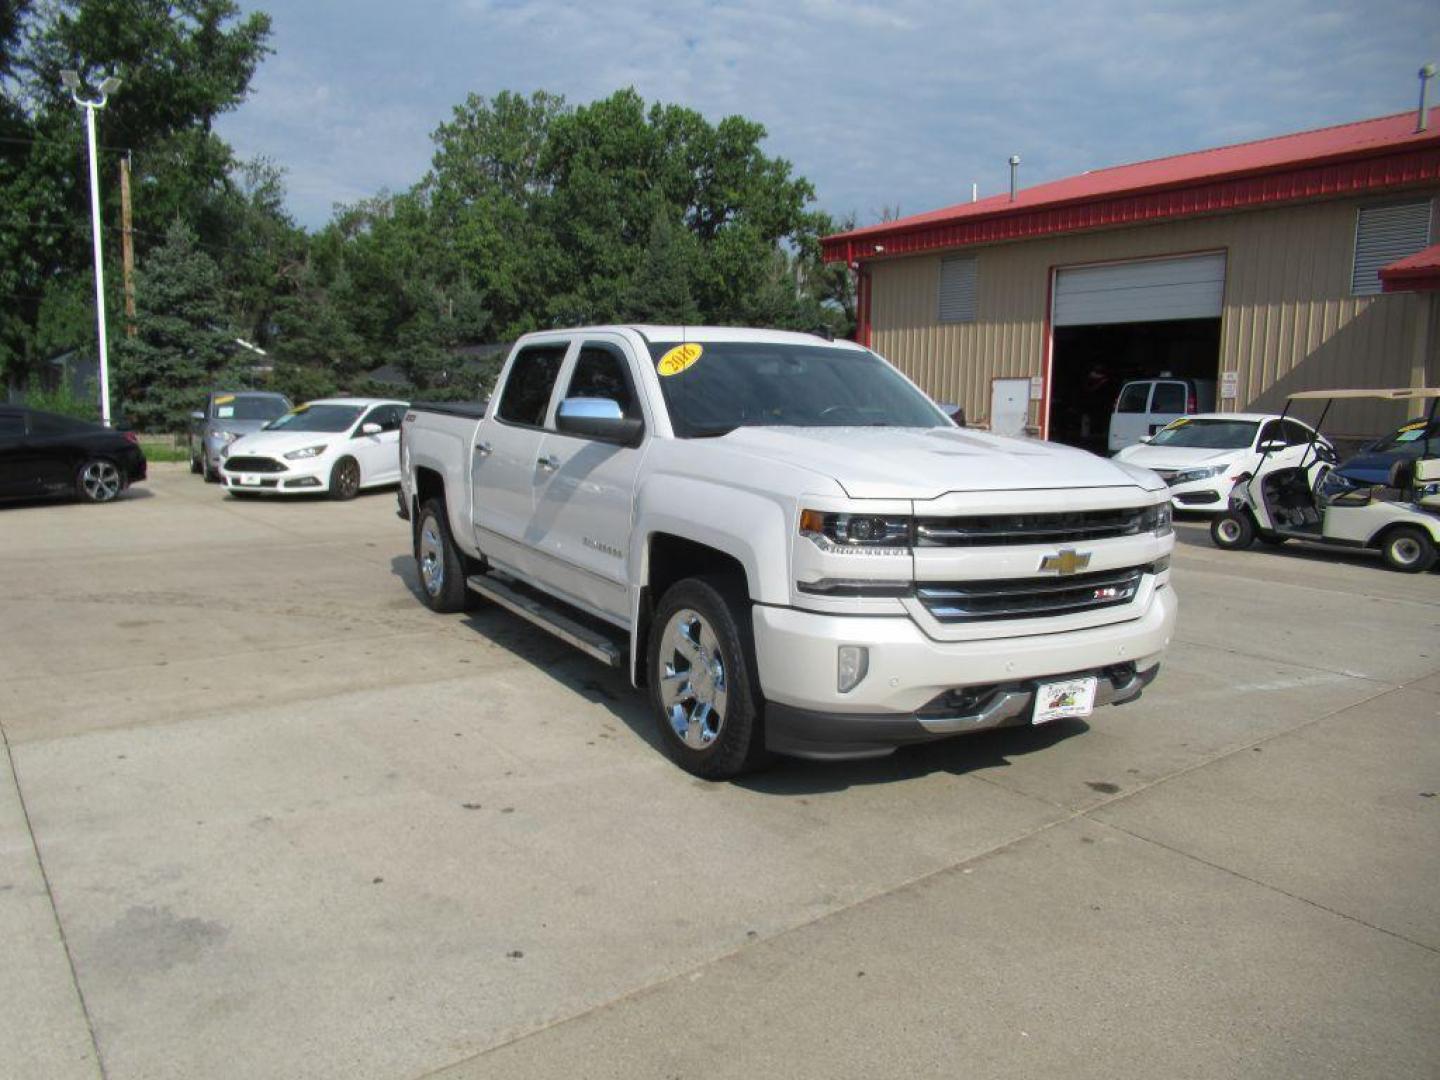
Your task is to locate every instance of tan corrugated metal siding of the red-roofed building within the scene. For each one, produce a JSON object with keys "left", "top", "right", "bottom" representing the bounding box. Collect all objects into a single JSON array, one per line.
[{"left": 870, "top": 194, "right": 1428, "bottom": 432}]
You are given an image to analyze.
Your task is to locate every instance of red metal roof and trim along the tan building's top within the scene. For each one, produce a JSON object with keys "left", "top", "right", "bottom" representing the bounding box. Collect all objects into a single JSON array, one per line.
[{"left": 822, "top": 117, "right": 1440, "bottom": 262}]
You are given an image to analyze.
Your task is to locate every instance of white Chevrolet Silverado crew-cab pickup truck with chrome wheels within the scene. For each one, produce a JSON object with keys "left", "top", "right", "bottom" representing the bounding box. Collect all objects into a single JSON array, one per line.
[{"left": 400, "top": 325, "right": 1175, "bottom": 778}]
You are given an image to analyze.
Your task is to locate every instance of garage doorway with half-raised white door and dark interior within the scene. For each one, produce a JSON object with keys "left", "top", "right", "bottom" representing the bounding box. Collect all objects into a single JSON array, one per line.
[{"left": 1048, "top": 253, "right": 1225, "bottom": 454}]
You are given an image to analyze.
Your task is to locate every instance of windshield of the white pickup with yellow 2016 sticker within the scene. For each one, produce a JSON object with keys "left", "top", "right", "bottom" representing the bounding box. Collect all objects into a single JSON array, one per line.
[{"left": 649, "top": 341, "right": 949, "bottom": 439}]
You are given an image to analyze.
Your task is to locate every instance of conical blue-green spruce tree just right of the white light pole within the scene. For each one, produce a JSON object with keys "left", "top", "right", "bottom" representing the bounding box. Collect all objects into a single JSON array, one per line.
[{"left": 114, "top": 222, "right": 239, "bottom": 432}]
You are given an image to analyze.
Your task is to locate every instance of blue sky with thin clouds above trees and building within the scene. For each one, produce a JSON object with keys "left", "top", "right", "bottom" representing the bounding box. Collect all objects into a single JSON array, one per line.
[{"left": 219, "top": 0, "right": 1440, "bottom": 229}]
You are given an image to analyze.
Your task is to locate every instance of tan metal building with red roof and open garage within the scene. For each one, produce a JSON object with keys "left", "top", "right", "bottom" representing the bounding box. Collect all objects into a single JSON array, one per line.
[{"left": 824, "top": 111, "right": 1440, "bottom": 448}]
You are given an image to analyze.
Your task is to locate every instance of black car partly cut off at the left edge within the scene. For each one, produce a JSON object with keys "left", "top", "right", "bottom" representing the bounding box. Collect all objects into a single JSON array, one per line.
[{"left": 0, "top": 405, "right": 145, "bottom": 503}]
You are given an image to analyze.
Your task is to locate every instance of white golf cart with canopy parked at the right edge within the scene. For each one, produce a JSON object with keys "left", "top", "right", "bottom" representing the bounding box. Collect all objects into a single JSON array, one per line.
[{"left": 1210, "top": 389, "right": 1440, "bottom": 573}]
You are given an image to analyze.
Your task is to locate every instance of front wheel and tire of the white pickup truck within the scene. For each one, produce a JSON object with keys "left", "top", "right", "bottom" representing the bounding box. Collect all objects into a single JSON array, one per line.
[{"left": 647, "top": 577, "right": 765, "bottom": 780}]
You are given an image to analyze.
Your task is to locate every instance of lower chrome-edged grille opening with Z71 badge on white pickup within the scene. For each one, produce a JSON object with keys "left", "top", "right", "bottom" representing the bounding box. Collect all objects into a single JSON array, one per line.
[{"left": 914, "top": 566, "right": 1149, "bottom": 624}]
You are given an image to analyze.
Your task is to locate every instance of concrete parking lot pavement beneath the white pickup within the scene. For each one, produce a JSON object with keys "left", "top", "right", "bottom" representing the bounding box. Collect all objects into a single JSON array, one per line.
[{"left": 0, "top": 465, "right": 1440, "bottom": 1080}]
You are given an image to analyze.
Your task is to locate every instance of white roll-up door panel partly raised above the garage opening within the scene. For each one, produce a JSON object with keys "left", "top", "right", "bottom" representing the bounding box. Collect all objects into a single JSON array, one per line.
[{"left": 1054, "top": 253, "right": 1225, "bottom": 327}]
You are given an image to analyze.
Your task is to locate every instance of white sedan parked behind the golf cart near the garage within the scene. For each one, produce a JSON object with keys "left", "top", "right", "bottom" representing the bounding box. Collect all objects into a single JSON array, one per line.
[{"left": 1115, "top": 412, "right": 1331, "bottom": 513}]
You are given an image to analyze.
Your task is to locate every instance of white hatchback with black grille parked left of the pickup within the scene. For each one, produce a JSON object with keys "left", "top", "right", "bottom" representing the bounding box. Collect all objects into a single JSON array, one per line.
[{"left": 220, "top": 397, "right": 406, "bottom": 500}]
